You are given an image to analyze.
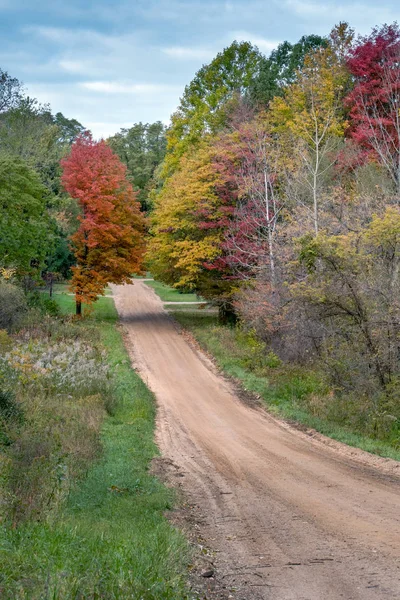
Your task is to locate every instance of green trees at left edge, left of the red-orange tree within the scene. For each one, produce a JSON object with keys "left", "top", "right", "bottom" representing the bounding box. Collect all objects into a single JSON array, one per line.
[{"left": 0, "top": 69, "right": 83, "bottom": 279}]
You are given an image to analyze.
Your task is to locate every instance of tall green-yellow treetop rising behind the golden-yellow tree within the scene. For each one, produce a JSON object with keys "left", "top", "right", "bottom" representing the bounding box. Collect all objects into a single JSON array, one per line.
[{"left": 162, "top": 41, "right": 262, "bottom": 178}]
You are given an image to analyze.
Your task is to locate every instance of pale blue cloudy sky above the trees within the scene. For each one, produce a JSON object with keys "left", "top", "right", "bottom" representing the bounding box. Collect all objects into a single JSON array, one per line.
[{"left": 0, "top": 0, "right": 400, "bottom": 137}]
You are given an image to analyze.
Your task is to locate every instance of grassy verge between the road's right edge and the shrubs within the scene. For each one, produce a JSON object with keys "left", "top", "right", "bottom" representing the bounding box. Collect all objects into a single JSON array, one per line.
[{"left": 146, "top": 286, "right": 400, "bottom": 460}]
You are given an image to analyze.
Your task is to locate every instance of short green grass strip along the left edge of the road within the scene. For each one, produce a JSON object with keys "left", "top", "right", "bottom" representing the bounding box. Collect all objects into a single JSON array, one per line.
[{"left": 0, "top": 294, "right": 188, "bottom": 600}]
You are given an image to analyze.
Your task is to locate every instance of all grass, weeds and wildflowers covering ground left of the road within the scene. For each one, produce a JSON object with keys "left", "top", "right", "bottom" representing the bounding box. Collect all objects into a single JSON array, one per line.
[{"left": 0, "top": 284, "right": 189, "bottom": 600}]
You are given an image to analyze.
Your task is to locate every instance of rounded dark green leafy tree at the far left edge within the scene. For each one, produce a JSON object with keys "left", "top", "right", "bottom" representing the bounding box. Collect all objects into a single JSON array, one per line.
[{"left": 0, "top": 154, "right": 54, "bottom": 274}]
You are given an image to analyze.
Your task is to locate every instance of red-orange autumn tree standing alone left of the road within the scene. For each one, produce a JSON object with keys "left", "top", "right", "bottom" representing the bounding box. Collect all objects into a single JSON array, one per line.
[{"left": 61, "top": 133, "right": 144, "bottom": 315}]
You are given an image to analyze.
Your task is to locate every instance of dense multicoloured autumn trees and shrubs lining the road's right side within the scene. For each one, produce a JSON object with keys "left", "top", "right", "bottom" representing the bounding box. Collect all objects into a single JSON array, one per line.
[{"left": 148, "top": 23, "right": 400, "bottom": 439}]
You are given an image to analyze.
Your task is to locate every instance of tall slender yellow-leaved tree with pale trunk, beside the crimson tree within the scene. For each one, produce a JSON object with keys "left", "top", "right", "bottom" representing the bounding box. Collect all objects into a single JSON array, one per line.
[{"left": 271, "top": 23, "right": 353, "bottom": 235}]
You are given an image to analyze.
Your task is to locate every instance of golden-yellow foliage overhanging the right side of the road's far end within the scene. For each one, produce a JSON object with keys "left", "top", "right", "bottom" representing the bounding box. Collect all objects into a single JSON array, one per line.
[{"left": 147, "top": 145, "right": 225, "bottom": 289}]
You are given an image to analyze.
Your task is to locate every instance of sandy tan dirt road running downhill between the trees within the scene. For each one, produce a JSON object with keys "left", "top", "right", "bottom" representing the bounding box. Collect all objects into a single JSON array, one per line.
[{"left": 113, "top": 281, "right": 400, "bottom": 600}]
